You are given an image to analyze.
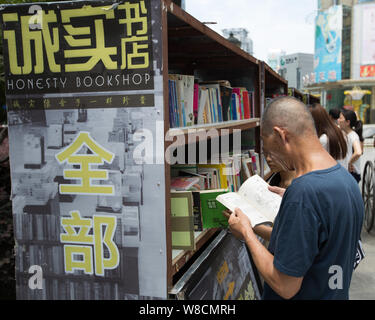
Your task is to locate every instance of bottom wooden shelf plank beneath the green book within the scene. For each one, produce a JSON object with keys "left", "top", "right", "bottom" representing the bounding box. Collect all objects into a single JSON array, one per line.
[{"left": 172, "top": 229, "right": 218, "bottom": 275}]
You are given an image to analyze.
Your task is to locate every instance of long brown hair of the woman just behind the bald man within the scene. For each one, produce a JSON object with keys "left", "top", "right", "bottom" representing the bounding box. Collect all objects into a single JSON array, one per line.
[{"left": 310, "top": 103, "right": 348, "bottom": 160}]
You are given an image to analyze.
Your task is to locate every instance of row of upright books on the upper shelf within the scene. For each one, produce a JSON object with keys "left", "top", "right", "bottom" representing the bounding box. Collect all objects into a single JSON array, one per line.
[{"left": 169, "top": 74, "right": 255, "bottom": 128}]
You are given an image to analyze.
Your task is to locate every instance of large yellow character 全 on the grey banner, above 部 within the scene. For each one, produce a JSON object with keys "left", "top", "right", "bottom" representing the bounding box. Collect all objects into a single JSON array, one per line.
[{"left": 56, "top": 132, "right": 114, "bottom": 195}]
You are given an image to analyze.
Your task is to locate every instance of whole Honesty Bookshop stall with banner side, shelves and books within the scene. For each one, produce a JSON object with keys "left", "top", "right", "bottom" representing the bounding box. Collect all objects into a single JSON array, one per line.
[{"left": 0, "top": 0, "right": 288, "bottom": 300}]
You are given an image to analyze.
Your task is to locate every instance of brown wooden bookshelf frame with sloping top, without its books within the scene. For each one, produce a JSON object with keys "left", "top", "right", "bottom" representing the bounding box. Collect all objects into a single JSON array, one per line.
[{"left": 162, "top": 0, "right": 288, "bottom": 291}]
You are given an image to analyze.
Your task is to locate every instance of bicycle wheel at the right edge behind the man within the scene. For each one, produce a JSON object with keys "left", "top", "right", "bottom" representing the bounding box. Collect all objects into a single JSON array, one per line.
[{"left": 362, "top": 161, "right": 375, "bottom": 232}]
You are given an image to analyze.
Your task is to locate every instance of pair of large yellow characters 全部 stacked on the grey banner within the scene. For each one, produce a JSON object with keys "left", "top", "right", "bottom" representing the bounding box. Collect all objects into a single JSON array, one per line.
[{"left": 56, "top": 132, "right": 119, "bottom": 276}]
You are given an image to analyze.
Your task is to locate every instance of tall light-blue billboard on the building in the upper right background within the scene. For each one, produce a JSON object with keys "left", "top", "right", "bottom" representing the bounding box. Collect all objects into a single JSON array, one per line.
[{"left": 313, "top": 6, "right": 343, "bottom": 83}]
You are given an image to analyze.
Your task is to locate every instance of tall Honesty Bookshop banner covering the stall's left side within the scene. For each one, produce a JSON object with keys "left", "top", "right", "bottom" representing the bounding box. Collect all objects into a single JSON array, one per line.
[{"left": 0, "top": 0, "right": 167, "bottom": 300}]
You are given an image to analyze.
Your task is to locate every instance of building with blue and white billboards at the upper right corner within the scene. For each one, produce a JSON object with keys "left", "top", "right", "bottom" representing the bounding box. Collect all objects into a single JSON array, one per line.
[{"left": 307, "top": 0, "right": 375, "bottom": 123}]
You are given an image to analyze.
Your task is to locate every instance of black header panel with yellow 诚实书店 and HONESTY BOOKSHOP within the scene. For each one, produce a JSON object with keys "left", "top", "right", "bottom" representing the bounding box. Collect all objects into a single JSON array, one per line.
[{"left": 2, "top": 0, "right": 154, "bottom": 97}]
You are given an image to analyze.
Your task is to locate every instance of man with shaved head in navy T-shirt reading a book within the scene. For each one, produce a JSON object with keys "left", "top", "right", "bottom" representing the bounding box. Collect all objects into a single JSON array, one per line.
[{"left": 229, "top": 97, "right": 364, "bottom": 300}]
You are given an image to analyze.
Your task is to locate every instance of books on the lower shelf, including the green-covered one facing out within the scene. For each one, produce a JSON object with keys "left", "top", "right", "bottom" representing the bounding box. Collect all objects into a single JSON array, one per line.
[{"left": 171, "top": 149, "right": 269, "bottom": 250}]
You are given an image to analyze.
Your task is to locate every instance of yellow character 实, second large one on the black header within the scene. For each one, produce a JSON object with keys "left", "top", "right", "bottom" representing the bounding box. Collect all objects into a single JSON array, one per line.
[{"left": 61, "top": 5, "right": 117, "bottom": 72}]
